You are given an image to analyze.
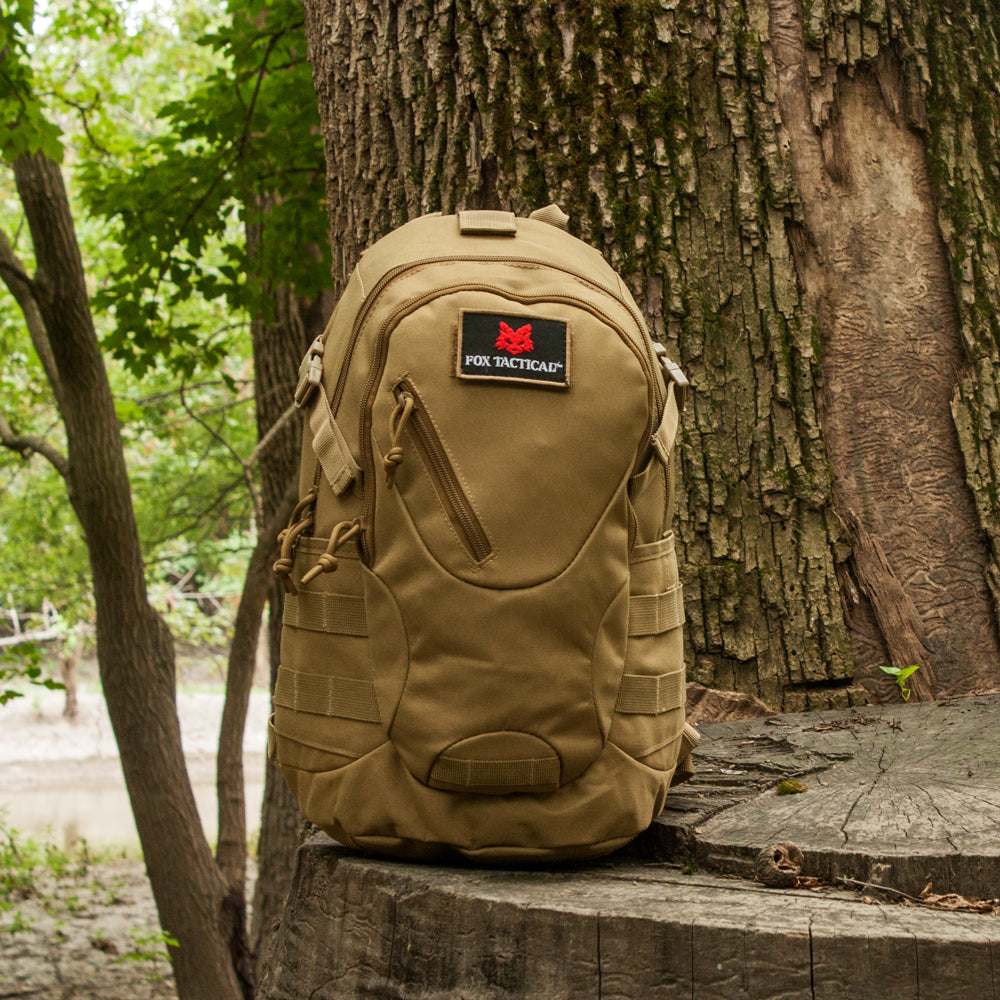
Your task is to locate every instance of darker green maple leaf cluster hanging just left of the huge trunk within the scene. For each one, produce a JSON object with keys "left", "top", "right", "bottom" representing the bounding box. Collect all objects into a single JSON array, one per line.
[{"left": 85, "top": 0, "right": 330, "bottom": 377}]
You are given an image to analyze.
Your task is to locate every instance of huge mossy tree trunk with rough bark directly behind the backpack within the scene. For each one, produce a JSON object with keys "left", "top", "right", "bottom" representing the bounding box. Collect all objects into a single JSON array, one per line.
[{"left": 305, "top": 0, "right": 1000, "bottom": 709}]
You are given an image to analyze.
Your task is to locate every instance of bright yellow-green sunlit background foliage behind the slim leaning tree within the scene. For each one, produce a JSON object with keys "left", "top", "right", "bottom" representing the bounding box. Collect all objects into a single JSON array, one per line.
[{"left": 0, "top": 0, "right": 296, "bottom": 670}]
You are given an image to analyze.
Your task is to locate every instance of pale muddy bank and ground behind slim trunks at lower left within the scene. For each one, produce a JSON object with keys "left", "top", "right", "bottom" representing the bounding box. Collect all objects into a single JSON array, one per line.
[{"left": 0, "top": 690, "right": 267, "bottom": 1000}]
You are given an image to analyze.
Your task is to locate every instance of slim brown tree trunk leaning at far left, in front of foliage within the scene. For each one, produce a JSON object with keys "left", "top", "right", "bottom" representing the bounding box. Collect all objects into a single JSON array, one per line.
[{"left": 14, "top": 155, "right": 241, "bottom": 1000}]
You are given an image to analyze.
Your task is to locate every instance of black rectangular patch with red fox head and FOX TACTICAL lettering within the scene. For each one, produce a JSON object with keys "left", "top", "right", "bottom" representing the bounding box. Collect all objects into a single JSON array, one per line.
[{"left": 456, "top": 310, "right": 569, "bottom": 387}]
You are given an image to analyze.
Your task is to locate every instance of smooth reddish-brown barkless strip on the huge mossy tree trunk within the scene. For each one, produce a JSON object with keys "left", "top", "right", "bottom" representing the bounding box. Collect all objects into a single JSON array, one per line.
[{"left": 770, "top": 0, "right": 1000, "bottom": 693}]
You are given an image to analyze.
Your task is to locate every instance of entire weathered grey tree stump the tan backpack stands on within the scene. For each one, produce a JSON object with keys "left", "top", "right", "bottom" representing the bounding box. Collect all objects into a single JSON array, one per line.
[{"left": 259, "top": 698, "right": 1000, "bottom": 1000}]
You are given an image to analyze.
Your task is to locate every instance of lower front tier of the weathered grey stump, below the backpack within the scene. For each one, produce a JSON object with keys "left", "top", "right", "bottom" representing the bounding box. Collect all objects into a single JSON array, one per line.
[{"left": 260, "top": 812, "right": 1000, "bottom": 1000}]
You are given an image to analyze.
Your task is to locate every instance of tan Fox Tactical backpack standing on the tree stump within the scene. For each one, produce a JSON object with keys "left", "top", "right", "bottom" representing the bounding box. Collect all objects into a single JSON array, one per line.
[{"left": 268, "top": 206, "right": 697, "bottom": 862}]
